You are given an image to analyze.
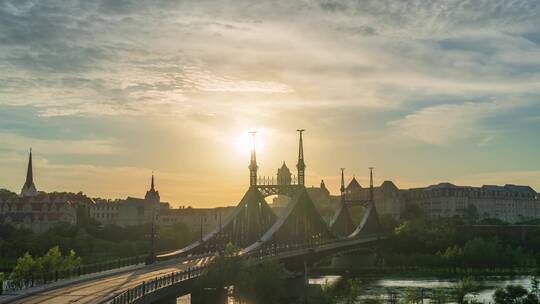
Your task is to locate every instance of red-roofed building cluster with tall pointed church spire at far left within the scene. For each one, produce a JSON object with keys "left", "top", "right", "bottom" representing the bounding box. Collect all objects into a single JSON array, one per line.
[{"left": 0, "top": 151, "right": 93, "bottom": 233}]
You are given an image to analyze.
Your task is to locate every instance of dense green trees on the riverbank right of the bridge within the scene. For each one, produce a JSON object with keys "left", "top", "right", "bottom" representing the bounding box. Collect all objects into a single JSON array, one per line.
[{"left": 379, "top": 214, "right": 540, "bottom": 270}]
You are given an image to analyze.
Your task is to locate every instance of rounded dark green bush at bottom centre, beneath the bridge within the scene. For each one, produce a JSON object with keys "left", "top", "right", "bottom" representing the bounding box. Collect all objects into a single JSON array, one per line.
[{"left": 234, "top": 261, "right": 287, "bottom": 304}]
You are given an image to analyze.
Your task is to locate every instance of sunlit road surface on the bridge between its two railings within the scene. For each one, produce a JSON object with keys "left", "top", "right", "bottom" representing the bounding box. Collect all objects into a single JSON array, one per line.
[{"left": 3, "top": 257, "right": 211, "bottom": 304}]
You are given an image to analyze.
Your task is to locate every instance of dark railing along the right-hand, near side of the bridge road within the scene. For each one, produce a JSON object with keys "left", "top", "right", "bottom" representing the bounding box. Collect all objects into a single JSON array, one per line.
[{"left": 102, "top": 266, "right": 206, "bottom": 304}]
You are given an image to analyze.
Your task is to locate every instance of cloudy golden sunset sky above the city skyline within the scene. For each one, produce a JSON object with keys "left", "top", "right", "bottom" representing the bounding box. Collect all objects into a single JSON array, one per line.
[{"left": 0, "top": 0, "right": 540, "bottom": 207}]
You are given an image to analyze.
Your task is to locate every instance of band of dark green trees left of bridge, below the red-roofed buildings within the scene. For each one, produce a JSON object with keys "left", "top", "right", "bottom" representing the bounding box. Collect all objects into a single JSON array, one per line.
[{"left": 0, "top": 218, "right": 194, "bottom": 268}]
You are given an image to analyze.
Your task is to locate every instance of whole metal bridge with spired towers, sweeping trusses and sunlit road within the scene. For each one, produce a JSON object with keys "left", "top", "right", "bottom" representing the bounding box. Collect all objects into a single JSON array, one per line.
[{"left": 0, "top": 130, "right": 385, "bottom": 304}]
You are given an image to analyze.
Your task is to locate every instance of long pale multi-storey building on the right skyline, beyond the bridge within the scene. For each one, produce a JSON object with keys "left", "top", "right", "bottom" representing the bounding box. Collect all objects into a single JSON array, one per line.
[{"left": 345, "top": 178, "right": 540, "bottom": 223}]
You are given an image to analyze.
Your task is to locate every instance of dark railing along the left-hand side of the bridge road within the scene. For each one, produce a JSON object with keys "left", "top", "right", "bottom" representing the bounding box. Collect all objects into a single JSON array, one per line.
[{"left": 0, "top": 256, "right": 146, "bottom": 295}]
